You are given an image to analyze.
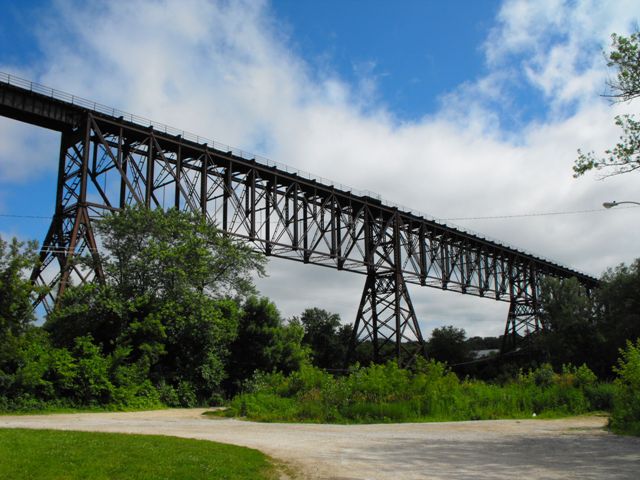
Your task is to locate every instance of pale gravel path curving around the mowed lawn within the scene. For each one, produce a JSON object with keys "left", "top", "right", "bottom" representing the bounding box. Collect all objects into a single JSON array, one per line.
[{"left": 0, "top": 409, "right": 640, "bottom": 480}]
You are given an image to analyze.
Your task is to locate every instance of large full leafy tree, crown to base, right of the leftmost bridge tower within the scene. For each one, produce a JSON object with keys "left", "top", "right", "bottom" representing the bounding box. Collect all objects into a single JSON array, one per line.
[{"left": 45, "top": 207, "right": 265, "bottom": 406}]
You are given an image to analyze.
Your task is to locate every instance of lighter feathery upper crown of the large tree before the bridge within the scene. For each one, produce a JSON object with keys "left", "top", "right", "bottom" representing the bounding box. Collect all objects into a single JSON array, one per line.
[{"left": 87, "top": 207, "right": 265, "bottom": 298}]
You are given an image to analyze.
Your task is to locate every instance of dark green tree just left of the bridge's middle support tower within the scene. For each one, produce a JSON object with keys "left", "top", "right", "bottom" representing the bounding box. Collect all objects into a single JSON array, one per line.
[{"left": 300, "top": 308, "right": 352, "bottom": 369}]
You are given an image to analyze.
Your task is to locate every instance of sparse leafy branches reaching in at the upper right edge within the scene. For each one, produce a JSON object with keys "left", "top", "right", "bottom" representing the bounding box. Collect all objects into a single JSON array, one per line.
[{"left": 573, "top": 32, "right": 640, "bottom": 178}]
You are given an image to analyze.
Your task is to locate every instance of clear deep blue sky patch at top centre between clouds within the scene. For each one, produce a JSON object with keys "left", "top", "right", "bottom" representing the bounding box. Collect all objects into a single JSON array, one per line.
[{"left": 273, "top": 0, "right": 499, "bottom": 120}]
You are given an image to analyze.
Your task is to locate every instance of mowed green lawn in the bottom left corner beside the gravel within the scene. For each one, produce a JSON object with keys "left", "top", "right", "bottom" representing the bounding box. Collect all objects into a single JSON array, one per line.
[{"left": 0, "top": 429, "right": 277, "bottom": 480}]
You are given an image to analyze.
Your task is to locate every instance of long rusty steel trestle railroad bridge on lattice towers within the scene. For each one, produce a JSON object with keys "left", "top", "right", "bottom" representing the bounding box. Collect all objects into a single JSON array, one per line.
[{"left": 0, "top": 73, "right": 598, "bottom": 364}]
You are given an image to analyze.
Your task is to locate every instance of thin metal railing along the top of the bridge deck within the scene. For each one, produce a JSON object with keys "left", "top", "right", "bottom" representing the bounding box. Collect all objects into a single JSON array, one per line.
[{"left": 0, "top": 72, "right": 580, "bottom": 272}]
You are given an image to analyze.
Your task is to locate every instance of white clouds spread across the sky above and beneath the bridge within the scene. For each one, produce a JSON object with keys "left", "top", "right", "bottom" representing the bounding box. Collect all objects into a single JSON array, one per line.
[{"left": 0, "top": 0, "right": 640, "bottom": 335}]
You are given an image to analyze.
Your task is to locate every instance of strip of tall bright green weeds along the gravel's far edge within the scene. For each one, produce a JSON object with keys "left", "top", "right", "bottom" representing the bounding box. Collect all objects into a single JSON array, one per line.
[{"left": 225, "top": 361, "right": 613, "bottom": 423}]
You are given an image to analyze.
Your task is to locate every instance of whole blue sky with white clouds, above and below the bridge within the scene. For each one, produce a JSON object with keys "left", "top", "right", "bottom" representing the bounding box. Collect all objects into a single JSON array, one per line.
[{"left": 0, "top": 0, "right": 640, "bottom": 336}]
